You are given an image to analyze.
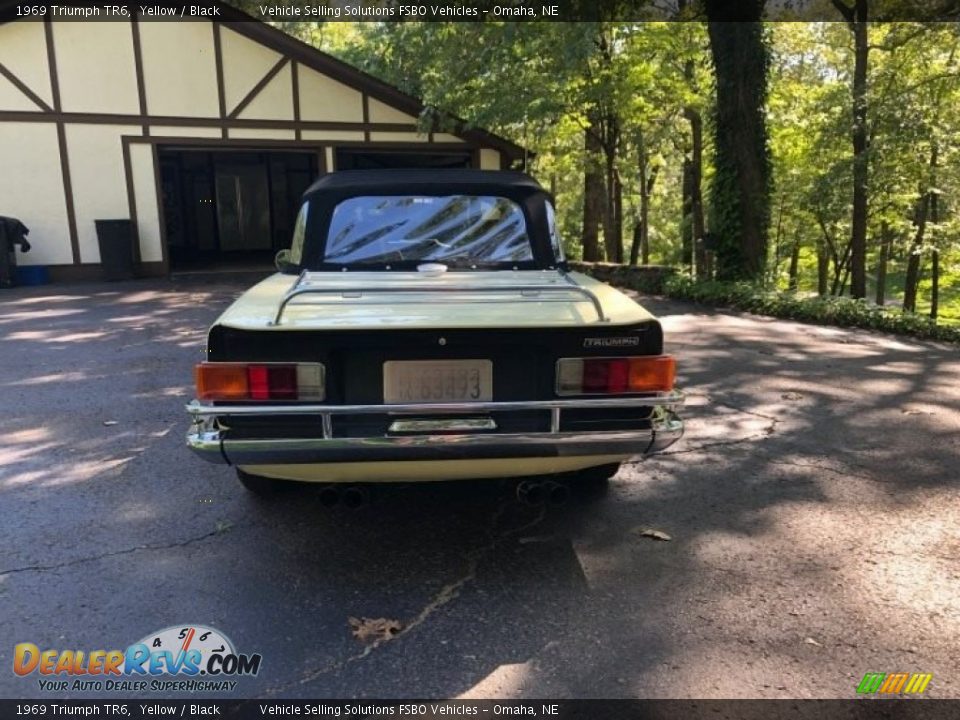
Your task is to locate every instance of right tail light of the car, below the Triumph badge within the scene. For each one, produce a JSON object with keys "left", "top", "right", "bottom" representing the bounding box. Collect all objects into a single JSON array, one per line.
[{"left": 557, "top": 355, "right": 676, "bottom": 395}]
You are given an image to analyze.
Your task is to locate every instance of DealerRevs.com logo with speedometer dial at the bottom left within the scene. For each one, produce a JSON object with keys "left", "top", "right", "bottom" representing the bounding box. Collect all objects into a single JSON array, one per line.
[{"left": 13, "top": 624, "right": 262, "bottom": 692}]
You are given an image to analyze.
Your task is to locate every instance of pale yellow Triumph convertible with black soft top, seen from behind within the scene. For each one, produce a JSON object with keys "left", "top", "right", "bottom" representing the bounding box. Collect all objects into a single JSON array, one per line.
[{"left": 187, "top": 170, "right": 683, "bottom": 495}]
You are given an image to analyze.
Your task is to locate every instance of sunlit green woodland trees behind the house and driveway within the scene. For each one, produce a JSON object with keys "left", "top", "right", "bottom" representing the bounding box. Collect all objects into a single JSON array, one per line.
[{"left": 270, "top": 17, "right": 960, "bottom": 322}]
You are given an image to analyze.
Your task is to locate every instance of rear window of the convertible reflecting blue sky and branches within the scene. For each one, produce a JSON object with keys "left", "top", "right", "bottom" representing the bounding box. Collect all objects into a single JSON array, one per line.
[{"left": 323, "top": 195, "right": 533, "bottom": 267}]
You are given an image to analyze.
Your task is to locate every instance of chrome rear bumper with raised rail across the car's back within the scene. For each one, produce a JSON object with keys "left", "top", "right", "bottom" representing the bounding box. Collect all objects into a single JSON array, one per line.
[{"left": 187, "top": 390, "right": 684, "bottom": 465}]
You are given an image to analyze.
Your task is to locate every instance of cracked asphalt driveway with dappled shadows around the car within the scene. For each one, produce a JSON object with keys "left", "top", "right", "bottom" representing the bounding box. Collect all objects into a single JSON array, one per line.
[{"left": 0, "top": 278, "right": 960, "bottom": 698}]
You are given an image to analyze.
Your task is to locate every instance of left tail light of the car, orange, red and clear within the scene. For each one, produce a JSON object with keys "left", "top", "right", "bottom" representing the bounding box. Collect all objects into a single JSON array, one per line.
[{"left": 195, "top": 363, "right": 326, "bottom": 401}]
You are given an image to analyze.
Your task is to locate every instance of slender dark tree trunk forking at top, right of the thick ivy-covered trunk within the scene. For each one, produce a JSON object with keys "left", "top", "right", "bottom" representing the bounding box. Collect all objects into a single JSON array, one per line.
[{"left": 832, "top": 0, "right": 870, "bottom": 298}]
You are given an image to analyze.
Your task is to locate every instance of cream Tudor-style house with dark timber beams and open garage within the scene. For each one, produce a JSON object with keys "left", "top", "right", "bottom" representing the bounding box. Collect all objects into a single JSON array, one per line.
[{"left": 0, "top": 0, "right": 524, "bottom": 279}]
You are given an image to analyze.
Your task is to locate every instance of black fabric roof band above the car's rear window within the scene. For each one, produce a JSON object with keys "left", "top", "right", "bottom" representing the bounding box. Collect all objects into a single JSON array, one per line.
[{"left": 303, "top": 169, "right": 545, "bottom": 199}]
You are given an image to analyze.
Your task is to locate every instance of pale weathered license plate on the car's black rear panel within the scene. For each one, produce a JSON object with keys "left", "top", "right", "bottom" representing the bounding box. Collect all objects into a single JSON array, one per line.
[{"left": 383, "top": 360, "right": 493, "bottom": 405}]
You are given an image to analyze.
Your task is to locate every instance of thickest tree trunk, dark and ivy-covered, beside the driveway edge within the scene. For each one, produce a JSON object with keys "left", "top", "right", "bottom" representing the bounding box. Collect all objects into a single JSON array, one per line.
[{"left": 706, "top": 11, "right": 770, "bottom": 280}]
